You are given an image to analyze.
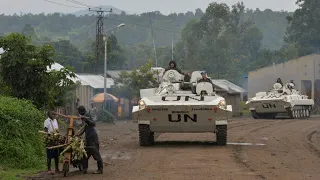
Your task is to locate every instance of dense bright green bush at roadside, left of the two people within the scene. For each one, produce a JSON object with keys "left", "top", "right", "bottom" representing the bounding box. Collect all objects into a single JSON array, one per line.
[{"left": 0, "top": 96, "right": 45, "bottom": 169}]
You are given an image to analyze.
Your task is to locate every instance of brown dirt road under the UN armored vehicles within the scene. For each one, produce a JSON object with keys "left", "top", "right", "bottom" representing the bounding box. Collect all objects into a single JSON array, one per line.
[{"left": 28, "top": 117, "right": 320, "bottom": 180}]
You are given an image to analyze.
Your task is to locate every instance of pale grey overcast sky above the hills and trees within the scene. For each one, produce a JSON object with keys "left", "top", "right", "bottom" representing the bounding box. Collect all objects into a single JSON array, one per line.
[{"left": 0, "top": 0, "right": 296, "bottom": 14}]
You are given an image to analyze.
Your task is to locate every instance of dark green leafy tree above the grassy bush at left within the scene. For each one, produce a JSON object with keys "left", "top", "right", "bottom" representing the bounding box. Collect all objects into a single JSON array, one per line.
[{"left": 0, "top": 33, "right": 75, "bottom": 108}]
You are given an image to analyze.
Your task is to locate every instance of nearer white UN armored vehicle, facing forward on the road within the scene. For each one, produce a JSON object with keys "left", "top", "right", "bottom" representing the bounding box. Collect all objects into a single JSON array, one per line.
[{"left": 132, "top": 70, "right": 232, "bottom": 146}]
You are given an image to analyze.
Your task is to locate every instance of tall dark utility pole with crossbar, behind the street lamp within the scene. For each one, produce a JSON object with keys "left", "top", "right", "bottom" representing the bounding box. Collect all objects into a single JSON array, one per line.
[{"left": 89, "top": 8, "right": 112, "bottom": 72}]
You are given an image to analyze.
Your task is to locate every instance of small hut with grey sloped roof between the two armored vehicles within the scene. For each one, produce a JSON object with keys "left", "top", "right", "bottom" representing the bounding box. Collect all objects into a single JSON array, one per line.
[{"left": 212, "top": 79, "right": 246, "bottom": 116}]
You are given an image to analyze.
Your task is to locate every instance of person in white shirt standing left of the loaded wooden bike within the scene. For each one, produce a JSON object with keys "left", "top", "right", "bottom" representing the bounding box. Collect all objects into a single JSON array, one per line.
[{"left": 44, "top": 110, "right": 59, "bottom": 173}]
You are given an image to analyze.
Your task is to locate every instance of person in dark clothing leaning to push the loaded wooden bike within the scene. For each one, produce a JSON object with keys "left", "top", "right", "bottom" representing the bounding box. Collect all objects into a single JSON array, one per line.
[{"left": 78, "top": 106, "right": 103, "bottom": 174}]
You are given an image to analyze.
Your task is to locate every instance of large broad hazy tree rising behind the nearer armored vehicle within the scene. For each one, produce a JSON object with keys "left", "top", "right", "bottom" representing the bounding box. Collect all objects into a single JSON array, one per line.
[{"left": 172, "top": 3, "right": 263, "bottom": 81}]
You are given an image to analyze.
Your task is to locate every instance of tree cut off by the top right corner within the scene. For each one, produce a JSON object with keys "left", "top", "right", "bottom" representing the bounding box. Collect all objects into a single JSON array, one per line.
[{"left": 285, "top": 0, "right": 320, "bottom": 55}]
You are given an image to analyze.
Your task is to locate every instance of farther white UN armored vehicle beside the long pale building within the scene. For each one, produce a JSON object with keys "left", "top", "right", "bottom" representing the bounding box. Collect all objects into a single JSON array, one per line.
[{"left": 246, "top": 83, "right": 314, "bottom": 119}]
